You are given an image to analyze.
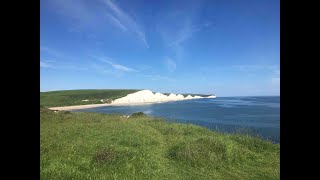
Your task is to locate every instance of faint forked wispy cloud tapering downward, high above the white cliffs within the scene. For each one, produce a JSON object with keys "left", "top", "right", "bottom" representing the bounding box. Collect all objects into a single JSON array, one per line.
[{"left": 157, "top": 4, "right": 211, "bottom": 72}]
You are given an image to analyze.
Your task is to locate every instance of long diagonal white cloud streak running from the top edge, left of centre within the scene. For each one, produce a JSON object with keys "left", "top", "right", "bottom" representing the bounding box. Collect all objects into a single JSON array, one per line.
[{"left": 103, "top": 0, "right": 149, "bottom": 48}]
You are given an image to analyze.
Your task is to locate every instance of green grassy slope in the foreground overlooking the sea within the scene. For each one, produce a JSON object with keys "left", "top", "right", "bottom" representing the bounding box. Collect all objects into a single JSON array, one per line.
[{"left": 40, "top": 108, "right": 280, "bottom": 179}]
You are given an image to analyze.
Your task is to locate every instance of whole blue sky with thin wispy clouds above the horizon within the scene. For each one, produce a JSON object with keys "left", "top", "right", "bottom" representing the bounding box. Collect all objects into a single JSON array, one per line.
[{"left": 40, "top": 0, "right": 280, "bottom": 96}]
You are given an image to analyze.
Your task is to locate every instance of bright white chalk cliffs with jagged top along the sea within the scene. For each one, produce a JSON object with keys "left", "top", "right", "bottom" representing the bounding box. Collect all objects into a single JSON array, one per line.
[{"left": 112, "top": 90, "right": 216, "bottom": 104}]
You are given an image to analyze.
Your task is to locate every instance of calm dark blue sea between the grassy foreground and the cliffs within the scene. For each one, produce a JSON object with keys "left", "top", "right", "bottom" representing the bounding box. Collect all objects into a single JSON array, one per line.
[{"left": 75, "top": 96, "right": 280, "bottom": 143}]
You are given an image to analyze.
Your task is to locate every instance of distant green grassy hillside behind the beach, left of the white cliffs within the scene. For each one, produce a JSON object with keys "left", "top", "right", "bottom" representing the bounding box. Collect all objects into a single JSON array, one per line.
[{"left": 40, "top": 89, "right": 139, "bottom": 107}]
